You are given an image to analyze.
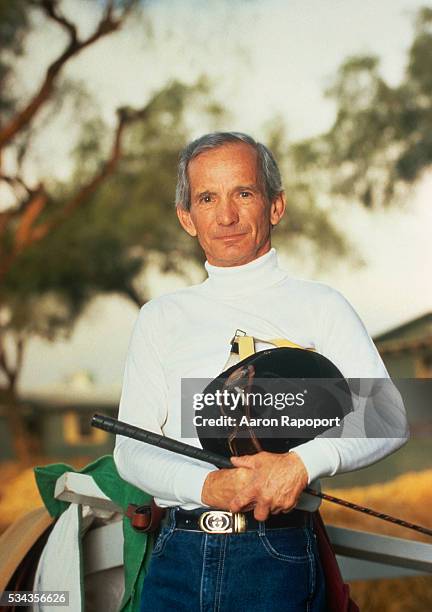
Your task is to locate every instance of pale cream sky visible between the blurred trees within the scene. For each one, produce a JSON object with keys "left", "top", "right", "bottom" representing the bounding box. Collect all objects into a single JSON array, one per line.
[{"left": 11, "top": 0, "right": 432, "bottom": 389}]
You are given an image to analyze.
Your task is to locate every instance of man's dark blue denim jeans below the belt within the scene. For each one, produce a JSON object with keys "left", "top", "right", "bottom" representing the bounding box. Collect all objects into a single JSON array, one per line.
[{"left": 141, "top": 512, "right": 326, "bottom": 612}]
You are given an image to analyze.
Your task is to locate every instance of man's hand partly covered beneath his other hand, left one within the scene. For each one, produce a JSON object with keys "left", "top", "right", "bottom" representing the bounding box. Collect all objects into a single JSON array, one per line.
[{"left": 201, "top": 467, "right": 254, "bottom": 510}]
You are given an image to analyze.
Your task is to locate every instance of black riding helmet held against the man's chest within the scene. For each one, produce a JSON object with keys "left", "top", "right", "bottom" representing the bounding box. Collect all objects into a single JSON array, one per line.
[{"left": 197, "top": 348, "right": 353, "bottom": 456}]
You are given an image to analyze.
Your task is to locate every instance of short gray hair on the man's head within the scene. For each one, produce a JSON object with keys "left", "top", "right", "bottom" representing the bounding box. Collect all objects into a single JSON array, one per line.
[{"left": 176, "top": 132, "right": 283, "bottom": 210}]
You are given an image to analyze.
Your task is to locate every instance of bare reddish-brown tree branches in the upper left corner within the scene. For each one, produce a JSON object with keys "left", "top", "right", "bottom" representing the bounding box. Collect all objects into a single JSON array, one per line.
[{"left": 0, "top": 0, "right": 146, "bottom": 281}]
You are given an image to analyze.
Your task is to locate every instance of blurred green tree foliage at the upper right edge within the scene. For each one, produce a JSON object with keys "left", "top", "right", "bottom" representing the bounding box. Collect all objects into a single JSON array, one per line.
[{"left": 295, "top": 8, "right": 432, "bottom": 208}]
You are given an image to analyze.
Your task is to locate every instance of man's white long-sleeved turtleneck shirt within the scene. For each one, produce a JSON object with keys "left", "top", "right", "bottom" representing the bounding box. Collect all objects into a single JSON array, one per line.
[{"left": 114, "top": 249, "right": 407, "bottom": 510}]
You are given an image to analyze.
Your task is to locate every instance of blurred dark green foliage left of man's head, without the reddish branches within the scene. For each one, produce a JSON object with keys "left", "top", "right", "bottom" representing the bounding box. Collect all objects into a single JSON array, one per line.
[{"left": 0, "top": 74, "right": 222, "bottom": 457}]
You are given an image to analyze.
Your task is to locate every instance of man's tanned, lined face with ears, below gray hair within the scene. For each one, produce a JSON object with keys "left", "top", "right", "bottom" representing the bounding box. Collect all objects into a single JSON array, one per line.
[{"left": 177, "top": 142, "right": 285, "bottom": 266}]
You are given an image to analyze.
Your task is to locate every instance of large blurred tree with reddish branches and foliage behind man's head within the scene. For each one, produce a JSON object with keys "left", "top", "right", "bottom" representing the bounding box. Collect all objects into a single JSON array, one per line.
[{"left": 0, "top": 0, "right": 352, "bottom": 464}]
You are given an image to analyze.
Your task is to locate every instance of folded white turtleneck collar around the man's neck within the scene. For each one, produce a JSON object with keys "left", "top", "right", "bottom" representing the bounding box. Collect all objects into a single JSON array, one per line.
[{"left": 203, "top": 248, "right": 287, "bottom": 296}]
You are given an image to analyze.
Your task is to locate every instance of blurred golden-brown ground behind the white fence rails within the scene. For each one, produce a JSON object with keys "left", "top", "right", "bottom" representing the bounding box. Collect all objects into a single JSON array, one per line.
[{"left": 0, "top": 457, "right": 432, "bottom": 612}]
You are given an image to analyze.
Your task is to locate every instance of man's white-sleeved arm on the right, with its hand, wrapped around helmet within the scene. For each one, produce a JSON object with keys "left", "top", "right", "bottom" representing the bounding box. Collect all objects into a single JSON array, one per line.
[{"left": 224, "top": 291, "right": 408, "bottom": 520}]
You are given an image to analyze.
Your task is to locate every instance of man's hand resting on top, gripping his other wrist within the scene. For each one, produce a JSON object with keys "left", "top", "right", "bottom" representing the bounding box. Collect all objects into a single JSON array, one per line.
[{"left": 227, "top": 451, "right": 308, "bottom": 521}]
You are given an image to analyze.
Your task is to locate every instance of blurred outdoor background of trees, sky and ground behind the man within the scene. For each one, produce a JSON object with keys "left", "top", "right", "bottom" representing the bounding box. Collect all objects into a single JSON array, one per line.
[{"left": 0, "top": 0, "right": 432, "bottom": 611}]
